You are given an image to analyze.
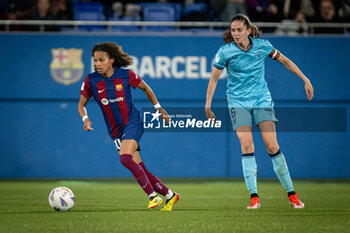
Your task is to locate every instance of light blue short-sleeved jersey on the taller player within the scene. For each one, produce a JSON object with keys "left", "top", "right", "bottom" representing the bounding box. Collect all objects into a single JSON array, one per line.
[{"left": 214, "top": 37, "right": 278, "bottom": 107}]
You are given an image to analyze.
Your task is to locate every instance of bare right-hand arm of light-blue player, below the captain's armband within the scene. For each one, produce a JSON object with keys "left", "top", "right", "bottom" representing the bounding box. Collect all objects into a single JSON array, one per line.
[{"left": 276, "top": 51, "right": 314, "bottom": 100}]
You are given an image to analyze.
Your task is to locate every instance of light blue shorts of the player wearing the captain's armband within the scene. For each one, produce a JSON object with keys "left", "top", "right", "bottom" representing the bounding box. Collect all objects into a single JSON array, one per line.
[{"left": 228, "top": 96, "right": 278, "bottom": 131}]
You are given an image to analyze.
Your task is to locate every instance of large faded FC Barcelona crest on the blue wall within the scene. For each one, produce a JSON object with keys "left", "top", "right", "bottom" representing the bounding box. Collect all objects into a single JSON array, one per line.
[{"left": 50, "top": 48, "right": 84, "bottom": 85}]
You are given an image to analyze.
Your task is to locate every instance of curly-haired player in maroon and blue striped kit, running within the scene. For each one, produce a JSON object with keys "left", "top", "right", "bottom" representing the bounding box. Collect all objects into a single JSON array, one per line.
[{"left": 78, "top": 42, "right": 179, "bottom": 211}]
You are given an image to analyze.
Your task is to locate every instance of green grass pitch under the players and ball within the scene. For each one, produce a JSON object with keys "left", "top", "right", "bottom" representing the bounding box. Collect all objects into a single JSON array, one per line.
[{"left": 0, "top": 179, "right": 350, "bottom": 233}]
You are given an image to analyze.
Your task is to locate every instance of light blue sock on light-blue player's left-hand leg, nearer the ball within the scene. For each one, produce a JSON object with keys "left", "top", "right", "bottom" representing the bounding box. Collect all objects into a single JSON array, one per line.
[{"left": 242, "top": 153, "right": 258, "bottom": 194}]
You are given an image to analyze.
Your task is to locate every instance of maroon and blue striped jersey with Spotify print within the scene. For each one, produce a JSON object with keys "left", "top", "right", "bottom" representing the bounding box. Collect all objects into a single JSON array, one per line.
[{"left": 80, "top": 67, "right": 141, "bottom": 139}]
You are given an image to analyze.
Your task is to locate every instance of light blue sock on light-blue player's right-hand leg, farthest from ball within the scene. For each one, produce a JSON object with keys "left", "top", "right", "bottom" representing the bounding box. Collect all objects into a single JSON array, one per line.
[{"left": 270, "top": 150, "right": 294, "bottom": 192}]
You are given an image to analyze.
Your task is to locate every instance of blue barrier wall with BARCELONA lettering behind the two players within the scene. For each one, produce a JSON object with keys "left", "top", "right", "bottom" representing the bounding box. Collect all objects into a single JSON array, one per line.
[{"left": 0, "top": 34, "right": 350, "bottom": 178}]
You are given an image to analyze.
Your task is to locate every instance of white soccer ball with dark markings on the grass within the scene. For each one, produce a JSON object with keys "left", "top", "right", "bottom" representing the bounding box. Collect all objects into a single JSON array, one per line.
[{"left": 49, "top": 186, "right": 74, "bottom": 211}]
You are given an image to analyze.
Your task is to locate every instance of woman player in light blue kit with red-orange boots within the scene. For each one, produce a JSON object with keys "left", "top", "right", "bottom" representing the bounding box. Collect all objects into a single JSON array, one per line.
[{"left": 205, "top": 14, "right": 314, "bottom": 209}]
